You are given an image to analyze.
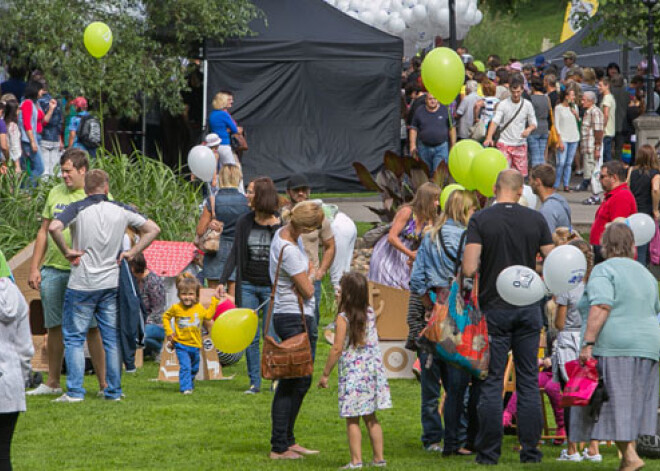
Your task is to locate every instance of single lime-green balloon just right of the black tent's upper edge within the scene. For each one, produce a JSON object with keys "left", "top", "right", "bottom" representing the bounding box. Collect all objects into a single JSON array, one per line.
[{"left": 422, "top": 47, "right": 465, "bottom": 105}]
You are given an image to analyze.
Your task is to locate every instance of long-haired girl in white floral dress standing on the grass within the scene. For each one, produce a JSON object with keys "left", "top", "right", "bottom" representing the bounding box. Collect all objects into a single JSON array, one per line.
[{"left": 319, "top": 272, "right": 392, "bottom": 469}]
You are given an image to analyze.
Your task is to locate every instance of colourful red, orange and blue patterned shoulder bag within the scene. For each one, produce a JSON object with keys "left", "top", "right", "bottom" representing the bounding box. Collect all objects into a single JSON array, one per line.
[{"left": 421, "top": 232, "right": 490, "bottom": 379}]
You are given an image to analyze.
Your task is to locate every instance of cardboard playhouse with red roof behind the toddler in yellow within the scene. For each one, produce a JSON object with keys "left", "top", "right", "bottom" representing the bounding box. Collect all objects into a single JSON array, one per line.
[{"left": 144, "top": 240, "right": 233, "bottom": 382}]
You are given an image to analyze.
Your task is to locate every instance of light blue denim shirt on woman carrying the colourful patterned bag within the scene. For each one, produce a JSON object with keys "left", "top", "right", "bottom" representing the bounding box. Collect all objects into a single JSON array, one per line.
[{"left": 410, "top": 219, "right": 465, "bottom": 296}]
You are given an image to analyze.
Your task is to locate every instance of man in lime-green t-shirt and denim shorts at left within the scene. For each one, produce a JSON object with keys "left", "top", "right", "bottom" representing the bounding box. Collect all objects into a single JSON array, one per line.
[{"left": 27, "top": 148, "right": 107, "bottom": 396}]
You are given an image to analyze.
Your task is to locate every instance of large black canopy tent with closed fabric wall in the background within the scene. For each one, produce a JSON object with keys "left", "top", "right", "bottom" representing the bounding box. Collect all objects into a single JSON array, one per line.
[{"left": 205, "top": 0, "right": 403, "bottom": 191}]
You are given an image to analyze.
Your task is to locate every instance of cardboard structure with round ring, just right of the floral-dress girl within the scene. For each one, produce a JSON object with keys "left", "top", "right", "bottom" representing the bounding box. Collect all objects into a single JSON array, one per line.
[{"left": 369, "top": 281, "right": 416, "bottom": 379}]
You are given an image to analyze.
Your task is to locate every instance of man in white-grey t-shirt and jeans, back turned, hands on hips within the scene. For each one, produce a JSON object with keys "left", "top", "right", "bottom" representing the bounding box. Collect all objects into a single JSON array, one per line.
[{"left": 48, "top": 169, "right": 160, "bottom": 402}]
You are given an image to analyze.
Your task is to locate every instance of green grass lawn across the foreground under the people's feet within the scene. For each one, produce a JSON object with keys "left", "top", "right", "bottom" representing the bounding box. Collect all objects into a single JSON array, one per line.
[{"left": 12, "top": 296, "right": 617, "bottom": 471}]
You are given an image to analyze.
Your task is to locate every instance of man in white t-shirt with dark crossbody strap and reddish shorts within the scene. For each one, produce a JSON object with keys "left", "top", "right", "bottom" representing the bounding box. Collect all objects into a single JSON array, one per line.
[{"left": 484, "top": 75, "right": 537, "bottom": 176}]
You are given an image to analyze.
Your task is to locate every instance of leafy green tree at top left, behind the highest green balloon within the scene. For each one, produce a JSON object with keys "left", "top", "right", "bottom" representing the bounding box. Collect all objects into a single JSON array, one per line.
[{"left": 0, "top": 0, "right": 259, "bottom": 117}]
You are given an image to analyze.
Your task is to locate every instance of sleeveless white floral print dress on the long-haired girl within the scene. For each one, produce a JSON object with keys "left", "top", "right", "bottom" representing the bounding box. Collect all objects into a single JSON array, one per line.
[{"left": 339, "top": 307, "right": 392, "bottom": 417}]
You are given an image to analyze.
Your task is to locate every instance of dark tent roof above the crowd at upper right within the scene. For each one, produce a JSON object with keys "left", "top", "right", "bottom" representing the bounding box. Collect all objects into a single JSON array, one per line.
[{"left": 524, "top": 21, "right": 645, "bottom": 67}]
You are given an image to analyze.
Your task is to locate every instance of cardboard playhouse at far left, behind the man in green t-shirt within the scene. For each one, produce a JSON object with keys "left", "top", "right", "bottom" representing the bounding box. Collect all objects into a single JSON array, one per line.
[{"left": 7, "top": 242, "right": 48, "bottom": 372}]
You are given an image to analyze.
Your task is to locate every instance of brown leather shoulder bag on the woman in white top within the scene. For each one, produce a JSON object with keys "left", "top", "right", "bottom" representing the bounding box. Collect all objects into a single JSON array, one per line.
[{"left": 261, "top": 244, "right": 314, "bottom": 380}]
